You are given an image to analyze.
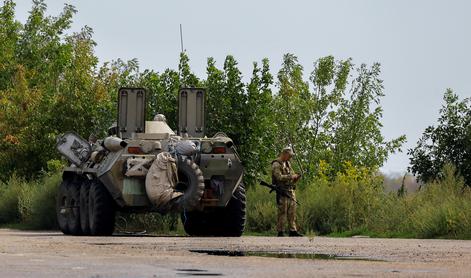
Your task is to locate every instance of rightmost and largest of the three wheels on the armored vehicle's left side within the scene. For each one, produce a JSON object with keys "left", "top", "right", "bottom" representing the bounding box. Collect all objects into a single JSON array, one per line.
[{"left": 88, "top": 180, "right": 116, "bottom": 236}]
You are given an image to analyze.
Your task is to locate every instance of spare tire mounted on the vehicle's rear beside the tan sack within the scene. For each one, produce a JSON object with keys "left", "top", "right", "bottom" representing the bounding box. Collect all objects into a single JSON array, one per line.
[{"left": 177, "top": 159, "right": 204, "bottom": 210}]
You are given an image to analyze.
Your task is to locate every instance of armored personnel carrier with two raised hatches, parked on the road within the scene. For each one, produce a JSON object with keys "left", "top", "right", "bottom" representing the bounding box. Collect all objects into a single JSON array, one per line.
[{"left": 56, "top": 88, "right": 246, "bottom": 236}]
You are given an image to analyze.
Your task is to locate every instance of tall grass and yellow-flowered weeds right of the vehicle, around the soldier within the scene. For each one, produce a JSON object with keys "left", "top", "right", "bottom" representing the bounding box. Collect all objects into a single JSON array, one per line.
[{"left": 247, "top": 164, "right": 471, "bottom": 238}]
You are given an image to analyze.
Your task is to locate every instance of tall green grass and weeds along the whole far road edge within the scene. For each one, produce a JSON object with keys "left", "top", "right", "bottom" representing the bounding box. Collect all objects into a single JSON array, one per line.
[{"left": 0, "top": 166, "right": 471, "bottom": 239}]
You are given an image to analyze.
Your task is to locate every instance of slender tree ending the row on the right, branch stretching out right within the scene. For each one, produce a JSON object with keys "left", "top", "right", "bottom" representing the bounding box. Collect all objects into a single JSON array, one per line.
[{"left": 331, "top": 63, "right": 405, "bottom": 176}]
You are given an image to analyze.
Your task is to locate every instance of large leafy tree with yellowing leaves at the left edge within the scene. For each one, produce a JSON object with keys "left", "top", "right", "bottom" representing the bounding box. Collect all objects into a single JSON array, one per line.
[{"left": 0, "top": 1, "right": 113, "bottom": 180}]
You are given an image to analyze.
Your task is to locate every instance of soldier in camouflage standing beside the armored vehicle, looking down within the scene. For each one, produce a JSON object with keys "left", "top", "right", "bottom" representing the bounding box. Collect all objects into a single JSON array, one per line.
[{"left": 271, "top": 147, "right": 302, "bottom": 236}]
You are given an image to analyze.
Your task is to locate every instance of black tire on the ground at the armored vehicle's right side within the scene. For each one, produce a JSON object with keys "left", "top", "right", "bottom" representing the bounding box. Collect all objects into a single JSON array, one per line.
[{"left": 181, "top": 184, "right": 246, "bottom": 237}]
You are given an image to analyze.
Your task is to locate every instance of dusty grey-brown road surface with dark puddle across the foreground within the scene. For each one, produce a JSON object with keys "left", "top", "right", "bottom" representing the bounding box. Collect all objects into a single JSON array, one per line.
[{"left": 0, "top": 229, "right": 471, "bottom": 278}]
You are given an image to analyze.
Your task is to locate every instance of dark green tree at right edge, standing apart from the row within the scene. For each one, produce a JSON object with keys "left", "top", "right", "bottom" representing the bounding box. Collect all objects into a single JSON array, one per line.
[{"left": 409, "top": 89, "right": 471, "bottom": 186}]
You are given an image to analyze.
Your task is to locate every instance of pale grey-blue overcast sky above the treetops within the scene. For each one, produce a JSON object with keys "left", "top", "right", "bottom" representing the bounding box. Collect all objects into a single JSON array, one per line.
[{"left": 16, "top": 0, "right": 471, "bottom": 173}]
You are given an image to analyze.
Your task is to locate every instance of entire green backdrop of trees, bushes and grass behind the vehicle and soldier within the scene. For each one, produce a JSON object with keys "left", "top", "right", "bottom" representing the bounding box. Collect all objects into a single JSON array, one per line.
[{"left": 0, "top": 0, "right": 471, "bottom": 238}]
